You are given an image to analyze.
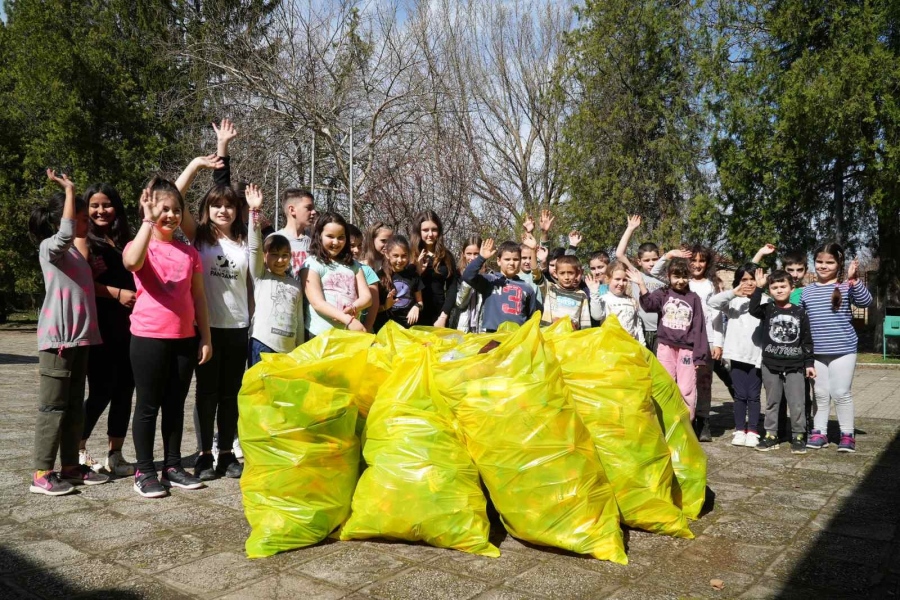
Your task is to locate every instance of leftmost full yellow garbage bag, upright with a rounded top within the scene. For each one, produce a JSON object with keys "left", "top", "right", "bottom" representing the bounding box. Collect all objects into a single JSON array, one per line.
[{"left": 238, "top": 353, "right": 364, "bottom": 558}]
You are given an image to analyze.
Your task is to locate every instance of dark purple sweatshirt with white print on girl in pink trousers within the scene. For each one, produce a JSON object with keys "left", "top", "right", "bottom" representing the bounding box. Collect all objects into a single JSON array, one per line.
[{"left": 641, "top": 287, "right": 709, "bottom": 365}]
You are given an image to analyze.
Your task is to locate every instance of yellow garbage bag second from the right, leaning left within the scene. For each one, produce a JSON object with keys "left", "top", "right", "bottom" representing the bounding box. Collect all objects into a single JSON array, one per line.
[{"left": 547, "top": 315, "right": 694, "bottom": 538}]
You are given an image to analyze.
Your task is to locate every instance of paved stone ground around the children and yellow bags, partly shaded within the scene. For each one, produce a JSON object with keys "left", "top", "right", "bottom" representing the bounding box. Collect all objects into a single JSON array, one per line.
[{"left": 0, "top": 332, "right": 900, "bottom": 600}]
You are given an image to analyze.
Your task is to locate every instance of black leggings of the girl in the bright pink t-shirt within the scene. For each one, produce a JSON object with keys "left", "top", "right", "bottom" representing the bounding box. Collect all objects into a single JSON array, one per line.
[{"left": 131, "top": 335, "right": 199, "bottom": 473}]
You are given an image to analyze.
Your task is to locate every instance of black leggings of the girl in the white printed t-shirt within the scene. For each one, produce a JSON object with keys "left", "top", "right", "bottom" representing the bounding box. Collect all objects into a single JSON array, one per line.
[{"left": 194, "top": 327, "right": 249, "bottom": 452}]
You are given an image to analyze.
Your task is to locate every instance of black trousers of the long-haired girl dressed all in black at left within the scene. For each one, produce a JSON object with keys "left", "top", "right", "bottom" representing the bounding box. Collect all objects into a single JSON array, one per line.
[{"left": 81, "top": 332, "right": 134, "bottom": 440}]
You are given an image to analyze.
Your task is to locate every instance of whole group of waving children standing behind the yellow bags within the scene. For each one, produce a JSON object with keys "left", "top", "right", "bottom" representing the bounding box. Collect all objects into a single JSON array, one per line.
[{"left": 30, "top": 120, "right": 872, "bottom": 498}]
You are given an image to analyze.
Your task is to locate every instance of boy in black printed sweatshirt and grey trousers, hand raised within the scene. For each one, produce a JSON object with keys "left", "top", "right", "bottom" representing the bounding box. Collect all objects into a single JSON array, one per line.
[{"left": 748, "top": 269, "right": 816, "bottom": 454}]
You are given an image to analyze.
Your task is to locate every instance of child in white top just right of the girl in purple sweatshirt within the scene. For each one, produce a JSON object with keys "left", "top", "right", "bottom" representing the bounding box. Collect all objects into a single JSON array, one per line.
[{"left": 652, "top": 244, "right": 731, "bottom": 442}]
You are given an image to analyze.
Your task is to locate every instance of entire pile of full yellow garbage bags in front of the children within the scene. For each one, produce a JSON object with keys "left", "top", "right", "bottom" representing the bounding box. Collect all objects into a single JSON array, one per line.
[{"left": 239, "top": 315, "right": 706, "bottom": 564}]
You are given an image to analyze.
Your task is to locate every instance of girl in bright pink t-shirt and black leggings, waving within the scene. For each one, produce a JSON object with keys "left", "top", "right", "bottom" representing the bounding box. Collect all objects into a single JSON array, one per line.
[{"left": 122, "top": 179, "right": 212, "bottom": 498}]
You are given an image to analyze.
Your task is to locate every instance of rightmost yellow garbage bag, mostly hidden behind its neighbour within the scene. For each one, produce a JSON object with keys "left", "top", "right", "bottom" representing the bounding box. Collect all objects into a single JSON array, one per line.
[{"left": 642, "top": 348, "right": 706, "bottom": 519}]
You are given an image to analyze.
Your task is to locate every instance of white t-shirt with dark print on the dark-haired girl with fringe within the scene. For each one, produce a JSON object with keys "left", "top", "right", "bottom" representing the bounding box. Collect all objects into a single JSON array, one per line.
[{"left": 197, "top": 238, "right": 250, "bottom": 329}]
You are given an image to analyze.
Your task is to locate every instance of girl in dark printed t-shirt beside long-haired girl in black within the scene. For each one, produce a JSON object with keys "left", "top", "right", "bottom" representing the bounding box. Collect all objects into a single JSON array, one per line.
[{"left": 376, "top": 235, "right": 424, "bottom": 329}]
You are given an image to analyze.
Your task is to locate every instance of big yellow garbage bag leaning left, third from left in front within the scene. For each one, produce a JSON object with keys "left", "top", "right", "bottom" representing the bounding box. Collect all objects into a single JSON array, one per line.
[{"left": 435, "top": 318, "right": 628, "bottom": 564}]
